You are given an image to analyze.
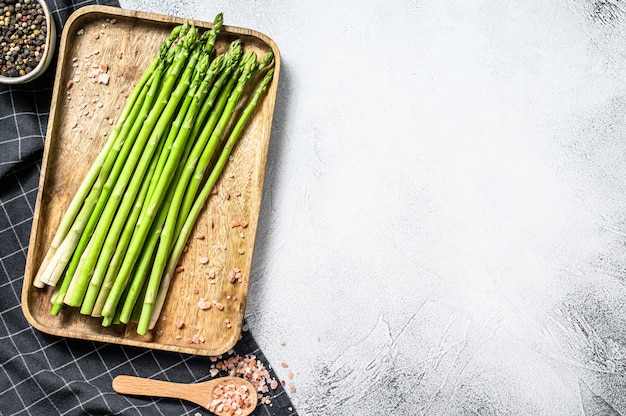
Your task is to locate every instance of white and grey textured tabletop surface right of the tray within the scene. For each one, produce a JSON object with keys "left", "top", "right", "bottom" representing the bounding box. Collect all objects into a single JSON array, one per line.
[{"left": 121, "top": 0, "right": 626, "bottom": 416}]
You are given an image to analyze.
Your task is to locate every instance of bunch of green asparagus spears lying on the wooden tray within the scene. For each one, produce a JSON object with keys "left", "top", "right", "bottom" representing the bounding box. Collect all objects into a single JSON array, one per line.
[{"left": 34, "top": 13, "right": 274, "bottom": 335}]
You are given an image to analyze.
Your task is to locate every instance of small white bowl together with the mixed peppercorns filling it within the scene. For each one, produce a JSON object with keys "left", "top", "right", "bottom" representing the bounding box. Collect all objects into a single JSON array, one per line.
[{"left": 0, "top": 0, "right": 56, "bottom": 84}]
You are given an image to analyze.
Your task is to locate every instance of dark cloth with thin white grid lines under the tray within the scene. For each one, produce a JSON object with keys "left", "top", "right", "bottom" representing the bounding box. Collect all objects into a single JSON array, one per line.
[{"left": 0, "top": 0, "right": 296, "bottom": 416}]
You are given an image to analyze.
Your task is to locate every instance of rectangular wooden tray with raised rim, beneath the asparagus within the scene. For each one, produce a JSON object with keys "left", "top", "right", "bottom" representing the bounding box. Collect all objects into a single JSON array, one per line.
[{"left": 22, "top": 6, "right": 280, "bottom": 355}]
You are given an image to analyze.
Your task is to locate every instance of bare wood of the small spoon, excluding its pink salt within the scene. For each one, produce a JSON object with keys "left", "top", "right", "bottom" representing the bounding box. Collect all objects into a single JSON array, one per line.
[{"left": 113, "top": 376, "right": 258, "bottom": 416}]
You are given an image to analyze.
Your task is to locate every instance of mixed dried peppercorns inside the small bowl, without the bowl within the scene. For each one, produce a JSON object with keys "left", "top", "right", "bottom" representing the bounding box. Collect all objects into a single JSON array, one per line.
[{"left": 0, "top": 0, "right": 48, "bottom": 77}]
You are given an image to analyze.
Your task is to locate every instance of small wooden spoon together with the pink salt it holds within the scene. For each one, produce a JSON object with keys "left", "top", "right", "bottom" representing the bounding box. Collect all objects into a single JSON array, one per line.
[{"left": 113, "top": 376, "right": 258, "bottom": 416}]
